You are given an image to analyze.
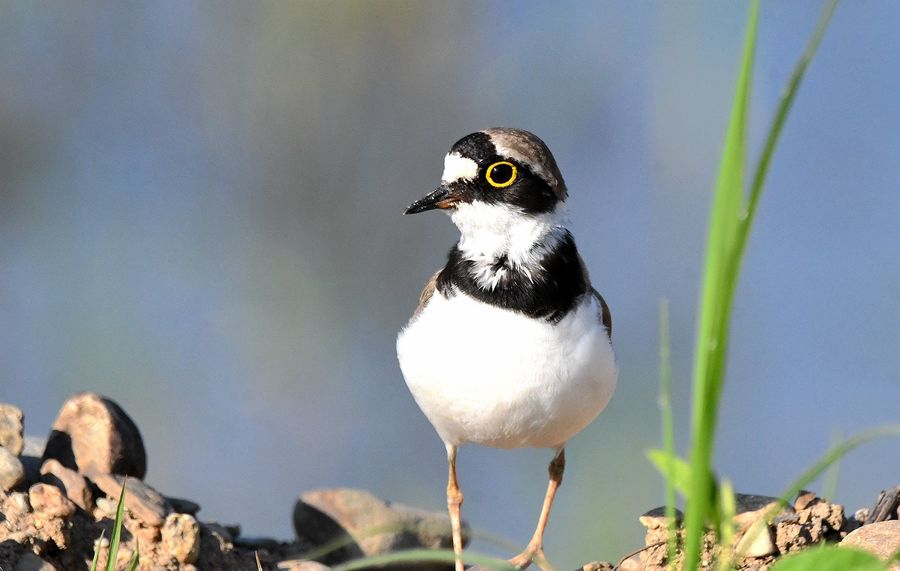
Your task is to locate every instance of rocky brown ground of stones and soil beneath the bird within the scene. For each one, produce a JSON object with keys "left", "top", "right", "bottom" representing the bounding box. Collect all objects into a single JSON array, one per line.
[{"left": 0, "top": 393, "right": 900, "bottom": 571}]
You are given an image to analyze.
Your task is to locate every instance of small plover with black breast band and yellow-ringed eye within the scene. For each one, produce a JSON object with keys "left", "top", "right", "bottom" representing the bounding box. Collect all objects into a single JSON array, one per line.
[{"left": 397, "top": 128, "right": 619, "bottom": 571}]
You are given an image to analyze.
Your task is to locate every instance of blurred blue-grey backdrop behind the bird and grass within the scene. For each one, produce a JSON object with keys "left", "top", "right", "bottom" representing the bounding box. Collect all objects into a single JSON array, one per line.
[{"left": 0, "top": 0, "right": 900, "bottom": 568}]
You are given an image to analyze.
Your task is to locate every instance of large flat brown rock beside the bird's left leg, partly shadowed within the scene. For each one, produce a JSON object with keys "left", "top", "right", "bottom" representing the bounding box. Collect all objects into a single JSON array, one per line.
[{"left": 294, "top": 488, "right": 469, "bottom": 563}]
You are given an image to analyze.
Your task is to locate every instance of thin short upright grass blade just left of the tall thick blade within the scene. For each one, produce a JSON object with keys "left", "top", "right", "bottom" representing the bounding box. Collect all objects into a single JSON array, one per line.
[{"left": 659, "top": 299, "right": 678, "bottom": 567}]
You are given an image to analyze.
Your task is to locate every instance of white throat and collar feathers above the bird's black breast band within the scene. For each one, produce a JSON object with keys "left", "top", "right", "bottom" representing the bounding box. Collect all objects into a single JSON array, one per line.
[{"left": 450, "top": 200, "right": 566, "bottom": 289}]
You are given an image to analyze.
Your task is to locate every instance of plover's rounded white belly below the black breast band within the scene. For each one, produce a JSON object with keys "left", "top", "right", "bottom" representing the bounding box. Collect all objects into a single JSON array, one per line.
[{"left": 397, "top": 291, "right": 618, "bottom": 448}]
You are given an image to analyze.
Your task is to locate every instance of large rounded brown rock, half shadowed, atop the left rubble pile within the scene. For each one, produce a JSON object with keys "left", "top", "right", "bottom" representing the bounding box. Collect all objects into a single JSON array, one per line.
[{"left": 43, "top": 393, "right": 147, "bottom": 478}]
